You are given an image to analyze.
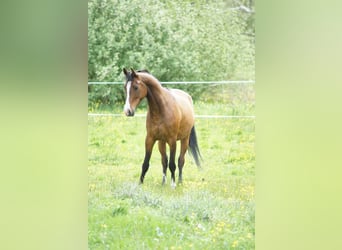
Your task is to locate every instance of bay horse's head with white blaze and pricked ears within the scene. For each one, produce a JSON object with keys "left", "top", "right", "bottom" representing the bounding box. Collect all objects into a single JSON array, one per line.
[{"left": 123, "top": 68, "right": 147, "bottom": 116}]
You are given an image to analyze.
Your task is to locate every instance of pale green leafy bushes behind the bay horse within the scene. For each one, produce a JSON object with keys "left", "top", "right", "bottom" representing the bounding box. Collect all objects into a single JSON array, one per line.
[{"left": 88, "top": 0, "right": 255, "bottom": 108}]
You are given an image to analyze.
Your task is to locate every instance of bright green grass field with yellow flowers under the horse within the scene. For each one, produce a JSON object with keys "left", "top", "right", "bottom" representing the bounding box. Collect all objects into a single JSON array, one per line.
[{"left": 88, "top": 92, "right": 255, "bottom": 249}]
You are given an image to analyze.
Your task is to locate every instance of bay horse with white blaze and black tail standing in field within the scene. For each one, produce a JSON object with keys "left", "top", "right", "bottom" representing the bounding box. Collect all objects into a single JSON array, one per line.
[{"left": 123, "top": 68, "right": 201, "bottom": 188}]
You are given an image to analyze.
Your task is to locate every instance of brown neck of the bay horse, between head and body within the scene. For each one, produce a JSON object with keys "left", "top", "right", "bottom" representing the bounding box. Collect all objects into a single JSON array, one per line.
[{"left": 140, "top": 75, "right": 169, "bottom": 116}]
